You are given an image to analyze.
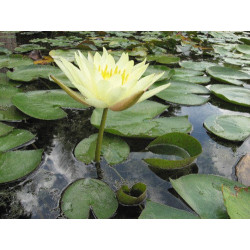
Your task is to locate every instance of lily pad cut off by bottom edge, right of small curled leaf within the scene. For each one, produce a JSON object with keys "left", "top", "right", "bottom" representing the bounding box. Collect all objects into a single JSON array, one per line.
[{"left": 139, "top": 201, "right": 199, "bottom": 219}]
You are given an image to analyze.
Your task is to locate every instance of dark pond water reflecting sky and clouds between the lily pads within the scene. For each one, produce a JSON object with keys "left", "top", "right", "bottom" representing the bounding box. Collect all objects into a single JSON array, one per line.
[{"left": 0, "top": 32, "right": 250, "bottom": 218}]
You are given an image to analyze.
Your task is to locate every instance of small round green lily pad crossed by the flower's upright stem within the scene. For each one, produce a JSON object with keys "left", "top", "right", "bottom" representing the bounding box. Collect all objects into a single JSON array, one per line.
[{"left": 74, "top": 134, "right": 130, "bottom": 165}]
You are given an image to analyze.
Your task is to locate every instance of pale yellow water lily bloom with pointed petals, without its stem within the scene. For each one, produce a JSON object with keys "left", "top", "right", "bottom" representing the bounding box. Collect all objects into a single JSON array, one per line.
[{"left": 51, "top": 48, "right": 170, "bottom": 111}]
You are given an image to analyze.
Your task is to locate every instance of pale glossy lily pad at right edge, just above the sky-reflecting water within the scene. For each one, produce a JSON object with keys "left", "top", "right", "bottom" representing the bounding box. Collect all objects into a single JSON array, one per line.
[{"left": 210, "top": 84, "right": 250, "bottom": 107}]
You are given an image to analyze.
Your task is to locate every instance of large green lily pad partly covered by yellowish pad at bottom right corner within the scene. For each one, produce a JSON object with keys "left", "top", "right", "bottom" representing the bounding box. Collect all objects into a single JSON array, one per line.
[{"left": 170, "top": 174, "right": 242, "bottom": 219}]
